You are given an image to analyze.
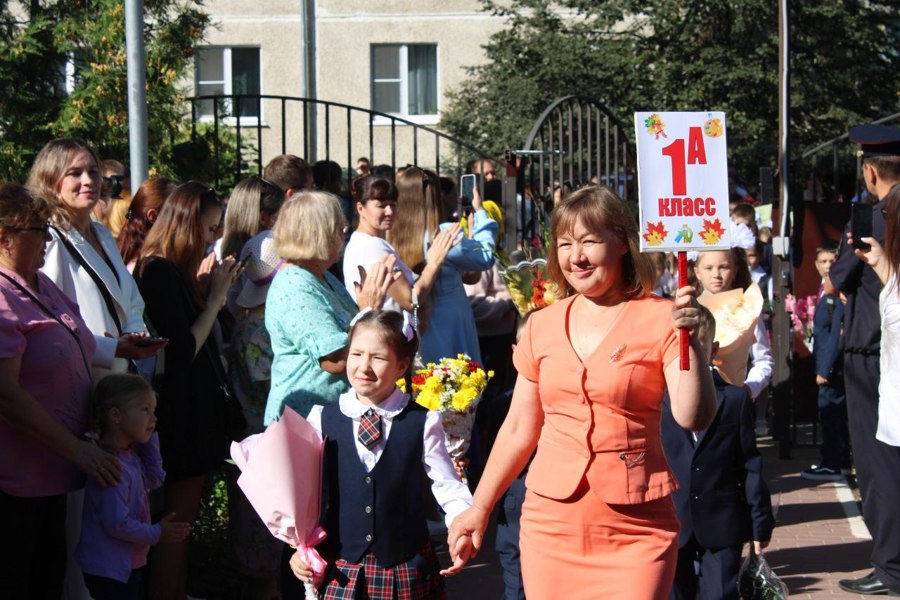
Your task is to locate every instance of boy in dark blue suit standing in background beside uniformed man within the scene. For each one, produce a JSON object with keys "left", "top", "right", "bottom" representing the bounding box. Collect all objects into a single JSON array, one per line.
[{"left": 800, "top": 242, "right": 850, "bottom": 481}]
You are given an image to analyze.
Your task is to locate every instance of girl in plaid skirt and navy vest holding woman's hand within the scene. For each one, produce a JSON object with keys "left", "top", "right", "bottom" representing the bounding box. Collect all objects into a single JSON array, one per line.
[{"left": 290, "top": 310, "right": 472, "bottom": 600}]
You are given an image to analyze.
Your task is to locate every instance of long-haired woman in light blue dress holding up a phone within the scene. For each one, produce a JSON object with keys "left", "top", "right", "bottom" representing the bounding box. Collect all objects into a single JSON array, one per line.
[{"left": 388, "top": 167, "right": 498, "bottom": 363}]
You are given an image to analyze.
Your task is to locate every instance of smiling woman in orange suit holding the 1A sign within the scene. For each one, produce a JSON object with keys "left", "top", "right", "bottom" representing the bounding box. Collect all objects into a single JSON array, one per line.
[{"left": 447, "top": 187, "right": 716, "bottom": 600}]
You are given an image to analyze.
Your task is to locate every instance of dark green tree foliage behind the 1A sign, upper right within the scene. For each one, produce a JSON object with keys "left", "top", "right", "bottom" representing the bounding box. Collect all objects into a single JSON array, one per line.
[{"left": 442, "top": 0, "right": 900, "bottom": 192}]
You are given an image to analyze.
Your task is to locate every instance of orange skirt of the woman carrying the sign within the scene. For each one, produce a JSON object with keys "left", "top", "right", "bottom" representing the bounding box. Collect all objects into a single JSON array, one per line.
[{"left": 519, "top": 480, "right": 678, "bottom": 600}]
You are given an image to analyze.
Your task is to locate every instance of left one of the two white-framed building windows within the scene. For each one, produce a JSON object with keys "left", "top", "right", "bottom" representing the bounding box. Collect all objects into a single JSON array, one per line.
[{"left": 195, "top": 48, "right": 261, "bottom": 121}]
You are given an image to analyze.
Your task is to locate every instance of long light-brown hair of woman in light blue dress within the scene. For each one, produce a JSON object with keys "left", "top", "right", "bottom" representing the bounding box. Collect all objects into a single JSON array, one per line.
[{"left": 387, "top": 167, "right": 441, "bottom": 271}]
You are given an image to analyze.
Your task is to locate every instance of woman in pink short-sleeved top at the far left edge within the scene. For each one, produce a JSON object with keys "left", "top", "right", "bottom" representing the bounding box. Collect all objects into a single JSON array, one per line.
[{"left": 0, "top": 183, "right": 121, "bottom": 598}]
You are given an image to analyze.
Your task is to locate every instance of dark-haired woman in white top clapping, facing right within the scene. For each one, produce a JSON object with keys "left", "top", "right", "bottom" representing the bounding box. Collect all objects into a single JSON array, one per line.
[{"left": 344, "top": 175, "right": 459, "bottom": 313}]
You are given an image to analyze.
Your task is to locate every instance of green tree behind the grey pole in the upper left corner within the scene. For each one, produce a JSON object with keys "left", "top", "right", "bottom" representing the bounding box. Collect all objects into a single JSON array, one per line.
[{"left": 0, "top": 0, "right": 209, "bottom": 180}]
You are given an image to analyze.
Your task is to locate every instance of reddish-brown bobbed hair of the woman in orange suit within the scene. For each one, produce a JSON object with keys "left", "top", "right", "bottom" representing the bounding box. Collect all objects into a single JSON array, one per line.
[{"left": 547, "top": 186, "right": 656, "bottom": 299}]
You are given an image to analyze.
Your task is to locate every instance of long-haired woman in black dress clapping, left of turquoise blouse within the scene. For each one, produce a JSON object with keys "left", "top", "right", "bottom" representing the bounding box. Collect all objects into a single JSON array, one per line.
[{"left": 135, "top": 181, "right": 240, "bottom": 598}]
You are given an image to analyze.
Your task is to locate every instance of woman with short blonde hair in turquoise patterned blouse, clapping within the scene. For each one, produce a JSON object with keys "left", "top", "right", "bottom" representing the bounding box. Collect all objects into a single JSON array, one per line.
[{"left": 264, "top": 192, "right": 399, "bottom": 425}]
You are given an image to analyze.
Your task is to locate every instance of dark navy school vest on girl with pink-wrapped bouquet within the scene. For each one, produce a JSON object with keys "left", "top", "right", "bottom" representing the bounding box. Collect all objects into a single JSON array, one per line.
[{"left": 322, "top": 402, "right": 428, "bottom": 568}]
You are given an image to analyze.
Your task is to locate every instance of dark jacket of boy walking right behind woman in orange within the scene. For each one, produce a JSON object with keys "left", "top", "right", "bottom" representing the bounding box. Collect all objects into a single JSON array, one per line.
[{"left": 661, "top": 370, "right": 775, "bottom": 548}]
